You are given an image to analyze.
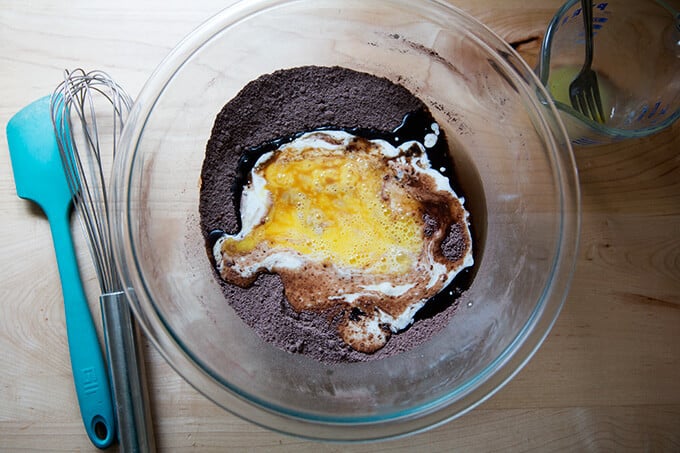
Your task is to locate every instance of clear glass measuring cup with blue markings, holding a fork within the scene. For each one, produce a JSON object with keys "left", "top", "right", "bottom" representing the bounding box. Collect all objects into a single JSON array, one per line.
[{"left": 537, "top": 0, "right": 680, "bottom": 145}]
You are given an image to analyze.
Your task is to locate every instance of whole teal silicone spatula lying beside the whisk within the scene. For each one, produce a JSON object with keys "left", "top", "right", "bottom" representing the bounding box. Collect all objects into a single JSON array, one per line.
[{"left": 7, "top": 96, "right": 116, "bottom": 448}]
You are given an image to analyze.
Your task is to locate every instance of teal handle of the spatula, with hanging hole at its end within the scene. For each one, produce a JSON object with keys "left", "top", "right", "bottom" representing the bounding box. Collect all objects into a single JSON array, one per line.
[{"left": 47, "top": 212, "right": 116, "bottom": 448}]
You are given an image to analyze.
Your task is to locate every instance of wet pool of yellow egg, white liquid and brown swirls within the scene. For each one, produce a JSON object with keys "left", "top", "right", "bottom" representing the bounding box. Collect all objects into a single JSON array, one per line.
[{"left": 213, "top": 129, "right": 472, "bottom": 352}]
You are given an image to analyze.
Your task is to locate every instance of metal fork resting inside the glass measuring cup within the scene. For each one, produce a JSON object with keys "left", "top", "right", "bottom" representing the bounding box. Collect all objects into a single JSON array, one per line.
[{"left": 569, "top": 0, "right": 605, "bottom": 123}]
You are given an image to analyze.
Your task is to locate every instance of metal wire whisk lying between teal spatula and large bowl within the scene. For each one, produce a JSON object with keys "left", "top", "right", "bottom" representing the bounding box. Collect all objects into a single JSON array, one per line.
[{"left": 50, "top": 69, "right": 155, "bottom": 452}]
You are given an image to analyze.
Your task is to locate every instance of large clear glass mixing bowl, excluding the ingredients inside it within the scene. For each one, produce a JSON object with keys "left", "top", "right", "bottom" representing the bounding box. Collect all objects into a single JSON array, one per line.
[{"left": 112, "top": 0, "right": 579, "bottom": 441}]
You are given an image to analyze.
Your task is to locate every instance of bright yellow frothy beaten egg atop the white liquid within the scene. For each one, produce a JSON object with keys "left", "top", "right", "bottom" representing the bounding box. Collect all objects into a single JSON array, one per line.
[{"left": 222, "top": 143, "right": 423, "bottom": 275}]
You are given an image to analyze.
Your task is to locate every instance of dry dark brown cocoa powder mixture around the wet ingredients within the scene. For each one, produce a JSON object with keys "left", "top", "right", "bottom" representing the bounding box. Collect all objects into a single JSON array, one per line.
[{"left": 199, "top": 66, "right": 467, "bottom": 362}]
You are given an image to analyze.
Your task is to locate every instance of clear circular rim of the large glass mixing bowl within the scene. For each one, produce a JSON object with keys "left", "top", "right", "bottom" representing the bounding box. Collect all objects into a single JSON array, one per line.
[{"left": 111, "top": 0, "right": 580, "bottom": 442}]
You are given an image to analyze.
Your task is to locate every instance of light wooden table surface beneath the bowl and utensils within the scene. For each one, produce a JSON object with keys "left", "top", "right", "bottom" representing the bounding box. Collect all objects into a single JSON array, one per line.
[{"left": 0, "top": 0, "right": 680, "bottom": 452}]
